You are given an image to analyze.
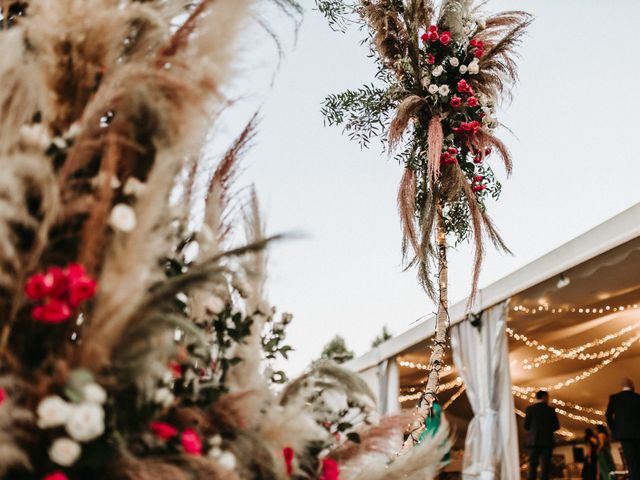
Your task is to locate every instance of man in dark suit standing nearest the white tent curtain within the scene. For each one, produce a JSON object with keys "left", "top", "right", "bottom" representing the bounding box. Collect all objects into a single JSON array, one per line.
[{"left": 524, "top": 390, "right": 560, "bottom": 480}]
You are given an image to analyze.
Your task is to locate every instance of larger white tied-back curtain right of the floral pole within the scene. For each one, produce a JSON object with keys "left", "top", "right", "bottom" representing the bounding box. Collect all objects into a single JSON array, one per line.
[{"left": 451, "top": 302, "right": 520, "bottom": 480}]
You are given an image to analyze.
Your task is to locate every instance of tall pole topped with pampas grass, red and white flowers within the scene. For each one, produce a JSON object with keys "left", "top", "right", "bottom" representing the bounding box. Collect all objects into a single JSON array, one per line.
[{"left": 316, "top": 0, "right": 531, "bottom": 441}]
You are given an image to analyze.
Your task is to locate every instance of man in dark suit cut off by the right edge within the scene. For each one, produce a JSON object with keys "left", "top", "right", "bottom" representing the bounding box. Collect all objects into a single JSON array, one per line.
[{"left": 606, "top": 378, "right": 640, "bottom": 480}]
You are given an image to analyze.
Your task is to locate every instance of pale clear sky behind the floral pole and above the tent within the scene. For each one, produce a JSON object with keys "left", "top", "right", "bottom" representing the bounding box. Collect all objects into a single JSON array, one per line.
[{"left": 215, "top": 0, "right": 640, "bottom": 372}]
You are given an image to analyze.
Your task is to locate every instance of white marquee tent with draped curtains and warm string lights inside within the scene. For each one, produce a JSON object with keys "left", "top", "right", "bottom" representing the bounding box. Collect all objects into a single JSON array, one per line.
[{"left": 347, "top": 204, "right": 640, "bottom": 479}]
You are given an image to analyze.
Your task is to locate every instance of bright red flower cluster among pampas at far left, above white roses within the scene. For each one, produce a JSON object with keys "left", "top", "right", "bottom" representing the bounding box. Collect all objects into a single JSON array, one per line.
[{"left": 25, "top": 263, "right": 96, "bottom": 323}]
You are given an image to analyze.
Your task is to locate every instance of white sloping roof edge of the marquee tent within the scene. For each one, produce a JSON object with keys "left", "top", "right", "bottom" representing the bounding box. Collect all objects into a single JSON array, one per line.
[{"left": 346, "top": 203, "right": 640, "bottom": 374}]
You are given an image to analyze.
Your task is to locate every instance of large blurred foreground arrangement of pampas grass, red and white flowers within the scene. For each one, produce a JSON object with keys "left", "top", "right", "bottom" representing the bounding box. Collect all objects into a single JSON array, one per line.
[{"left": 0, "top": 0, "right": 446, "bottom": 480}]
